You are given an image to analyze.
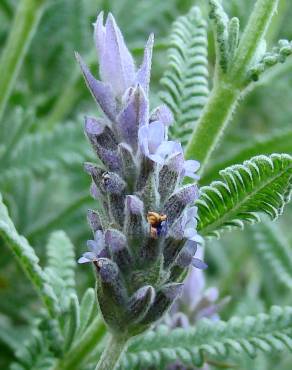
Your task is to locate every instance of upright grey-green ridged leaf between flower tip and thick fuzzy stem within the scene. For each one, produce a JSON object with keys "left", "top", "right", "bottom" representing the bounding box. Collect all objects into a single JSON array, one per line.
[{"left": 160, "top": 7, "right": 209, "bottom": 144}]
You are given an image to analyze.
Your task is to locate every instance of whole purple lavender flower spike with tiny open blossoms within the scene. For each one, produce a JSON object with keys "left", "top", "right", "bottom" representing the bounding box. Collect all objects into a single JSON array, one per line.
[{"left": 77, "top": 13, "right": 202, "bottom": 337}]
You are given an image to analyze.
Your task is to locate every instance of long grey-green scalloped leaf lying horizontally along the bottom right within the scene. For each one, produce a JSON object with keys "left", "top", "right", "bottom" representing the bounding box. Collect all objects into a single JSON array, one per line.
[{"left": 119, "top": 306, "right": 292, "bottom": 370}]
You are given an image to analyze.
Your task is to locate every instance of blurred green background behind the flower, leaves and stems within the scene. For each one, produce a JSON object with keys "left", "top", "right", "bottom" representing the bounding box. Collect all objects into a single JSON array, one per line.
[{"left": 0, "top": 0, "right": 292, "bottom": 370}]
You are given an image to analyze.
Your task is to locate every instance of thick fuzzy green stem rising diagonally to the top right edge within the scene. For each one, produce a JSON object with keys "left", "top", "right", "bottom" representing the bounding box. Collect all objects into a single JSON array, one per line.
[{"left": 186, "top": 0, "right": 279, "bottom": 173}]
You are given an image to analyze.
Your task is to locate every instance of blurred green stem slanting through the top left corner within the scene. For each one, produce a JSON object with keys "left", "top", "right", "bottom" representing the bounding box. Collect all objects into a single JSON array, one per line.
[{"left": 0, "top": 0, "right": 44, "bottom": 121}]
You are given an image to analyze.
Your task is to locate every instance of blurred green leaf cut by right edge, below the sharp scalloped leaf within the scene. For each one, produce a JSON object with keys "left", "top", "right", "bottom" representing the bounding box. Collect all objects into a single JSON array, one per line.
[{"left": 252, "top": 222, "right": 292, "bottom": 289}]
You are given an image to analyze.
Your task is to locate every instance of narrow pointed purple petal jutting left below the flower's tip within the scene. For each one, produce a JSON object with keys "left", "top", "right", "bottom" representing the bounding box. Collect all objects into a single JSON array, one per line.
[{"left": 75, "top": 53, "right": 117, "bottom": 120}]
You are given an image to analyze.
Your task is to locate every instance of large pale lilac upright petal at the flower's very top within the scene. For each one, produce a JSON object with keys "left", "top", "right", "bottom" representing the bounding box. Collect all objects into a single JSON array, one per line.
[{"left": 99, "top": 14, "right": 135, "bottom": 96}]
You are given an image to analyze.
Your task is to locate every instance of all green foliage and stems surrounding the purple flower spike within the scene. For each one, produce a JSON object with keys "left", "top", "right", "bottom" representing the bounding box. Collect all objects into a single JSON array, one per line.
[{"left": 0, "top": 0, "right": 292, "bottom": 370}]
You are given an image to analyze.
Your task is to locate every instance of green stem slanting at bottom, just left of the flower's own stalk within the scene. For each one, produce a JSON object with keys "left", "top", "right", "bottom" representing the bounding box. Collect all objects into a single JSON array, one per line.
[{"left": 54, "top": 318, "right": 106, "bottom": 370}]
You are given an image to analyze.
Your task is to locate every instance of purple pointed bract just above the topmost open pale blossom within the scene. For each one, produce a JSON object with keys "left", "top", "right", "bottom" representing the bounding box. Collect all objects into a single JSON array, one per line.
[{"left": 117, "top": 85, "right": 149, "bottom": 151}]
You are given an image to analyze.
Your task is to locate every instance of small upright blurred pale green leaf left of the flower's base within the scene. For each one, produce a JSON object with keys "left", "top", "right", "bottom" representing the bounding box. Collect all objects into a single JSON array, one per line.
[{"left": 45, "top": 231, "right": 76, "bottom": 310}]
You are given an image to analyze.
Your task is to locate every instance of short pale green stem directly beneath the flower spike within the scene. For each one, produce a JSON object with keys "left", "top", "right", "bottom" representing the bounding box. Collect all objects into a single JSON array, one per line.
[{"left": 95, "top": 335, "right": 128, "bottom": 370}]
